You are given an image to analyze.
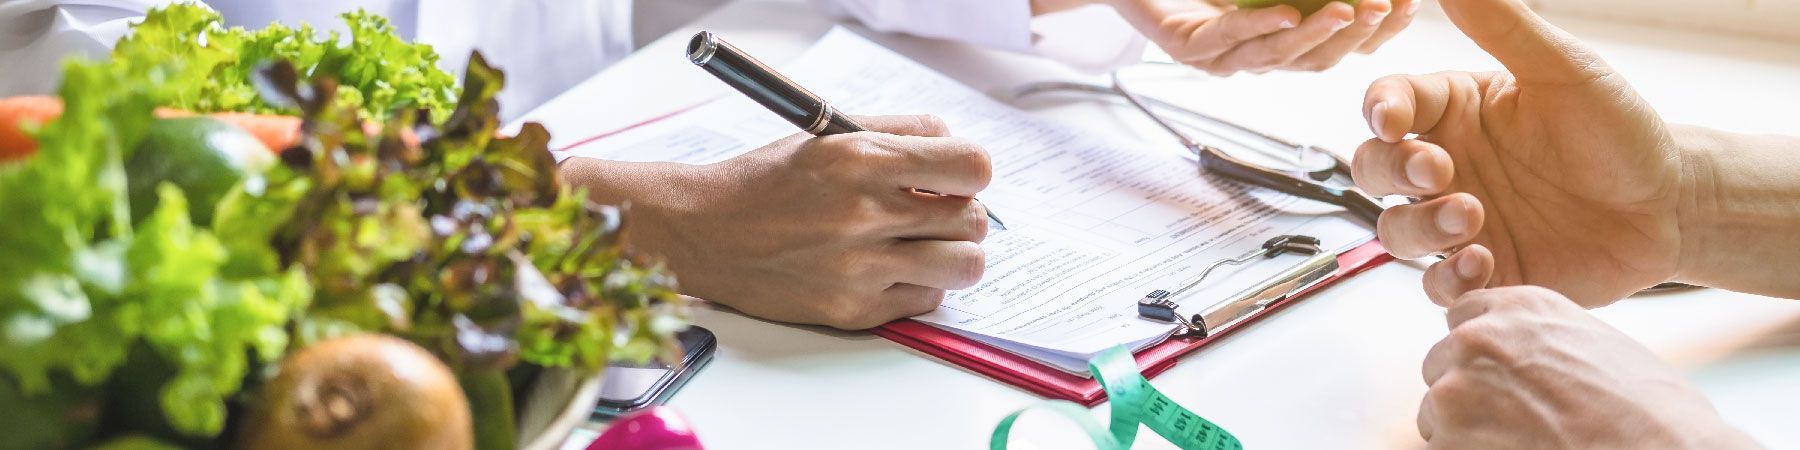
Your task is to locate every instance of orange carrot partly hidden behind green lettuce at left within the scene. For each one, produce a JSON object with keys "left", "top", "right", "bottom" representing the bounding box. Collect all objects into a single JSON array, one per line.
[{"left": 0, "top": 95, "right": 301, "bottom": 162}]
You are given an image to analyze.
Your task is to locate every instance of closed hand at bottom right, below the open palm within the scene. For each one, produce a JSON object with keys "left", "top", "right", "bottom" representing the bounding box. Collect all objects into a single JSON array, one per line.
[{"left": 1418, "top": 286, "right": 1757, "bottom": 448}]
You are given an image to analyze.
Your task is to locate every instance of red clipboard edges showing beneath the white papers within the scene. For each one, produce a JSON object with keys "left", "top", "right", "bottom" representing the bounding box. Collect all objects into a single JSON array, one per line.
[{"left": 873, "top": 241, "right": 1393, "bottom": 407}]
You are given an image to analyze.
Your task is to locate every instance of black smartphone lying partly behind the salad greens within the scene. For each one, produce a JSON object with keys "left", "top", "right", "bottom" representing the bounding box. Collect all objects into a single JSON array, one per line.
[{"left": 594, "top": 326, "right": 718, "bottom": 418}]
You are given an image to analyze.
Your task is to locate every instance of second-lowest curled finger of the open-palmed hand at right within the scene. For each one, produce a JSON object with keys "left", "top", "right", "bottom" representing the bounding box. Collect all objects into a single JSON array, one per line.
[{"left": 1375, "top": 193, "right": 1485, "bottom": 259}]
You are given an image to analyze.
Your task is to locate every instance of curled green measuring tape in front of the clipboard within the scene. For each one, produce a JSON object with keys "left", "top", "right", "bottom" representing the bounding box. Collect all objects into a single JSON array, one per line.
[{"left": 988, "top": 346, "right": 1244, "bottom": 450}]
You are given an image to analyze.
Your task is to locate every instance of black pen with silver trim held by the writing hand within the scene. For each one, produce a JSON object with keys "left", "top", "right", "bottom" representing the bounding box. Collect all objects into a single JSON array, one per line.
[{"left": 688, "top": 31, "right": 1006, "bottom": 230}]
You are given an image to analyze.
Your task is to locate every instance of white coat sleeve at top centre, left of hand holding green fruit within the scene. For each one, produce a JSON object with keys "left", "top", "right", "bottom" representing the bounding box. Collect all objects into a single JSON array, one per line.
[{"left": 812, "top": 0, "right": 1147, "bottom": 72}]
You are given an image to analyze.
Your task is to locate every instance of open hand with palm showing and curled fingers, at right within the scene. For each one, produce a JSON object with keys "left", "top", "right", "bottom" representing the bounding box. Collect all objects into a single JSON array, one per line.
[{"left": 1354, "top": 0, "right": 1683, "bottom": 308}]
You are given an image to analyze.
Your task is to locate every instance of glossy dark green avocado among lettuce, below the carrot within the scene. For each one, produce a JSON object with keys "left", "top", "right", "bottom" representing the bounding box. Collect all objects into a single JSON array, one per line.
[{"left": 124, "top": 117, "right": 275, "bottom": 227}]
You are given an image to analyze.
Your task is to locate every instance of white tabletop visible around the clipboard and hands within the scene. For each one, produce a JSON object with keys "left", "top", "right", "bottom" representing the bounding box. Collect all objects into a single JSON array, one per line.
[{"left": 526, "top": 2, "right": 1800, "bottom": 450}]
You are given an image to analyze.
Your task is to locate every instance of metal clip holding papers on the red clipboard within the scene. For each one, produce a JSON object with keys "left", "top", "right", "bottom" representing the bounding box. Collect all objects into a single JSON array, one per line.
[{"left": 1138, "top": 234, "right": 1337, "bottom": 338}]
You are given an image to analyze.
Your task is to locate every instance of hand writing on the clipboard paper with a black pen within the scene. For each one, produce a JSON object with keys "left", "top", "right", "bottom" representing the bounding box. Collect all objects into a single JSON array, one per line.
[{"left": 562, "top": 30, "right": 992, "bottom": 329}]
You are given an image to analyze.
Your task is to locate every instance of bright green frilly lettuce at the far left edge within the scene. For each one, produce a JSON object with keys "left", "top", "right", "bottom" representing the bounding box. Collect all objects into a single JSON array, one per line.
[{"left": 0, "top": 52, "right": 311, "bottom": 436}]
